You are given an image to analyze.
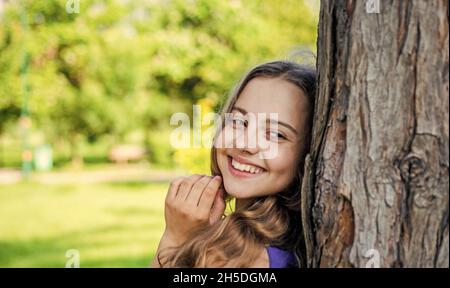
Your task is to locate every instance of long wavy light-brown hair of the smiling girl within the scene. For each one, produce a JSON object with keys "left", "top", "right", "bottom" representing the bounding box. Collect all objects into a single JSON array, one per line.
[{"left": 157, "top": 61, "right": 316, "bottom": 268}]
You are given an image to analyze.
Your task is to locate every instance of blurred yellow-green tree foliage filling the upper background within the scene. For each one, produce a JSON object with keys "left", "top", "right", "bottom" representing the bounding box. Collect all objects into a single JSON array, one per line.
[{"left": 0, "top": 0, "right": 317, "bottom": 164}]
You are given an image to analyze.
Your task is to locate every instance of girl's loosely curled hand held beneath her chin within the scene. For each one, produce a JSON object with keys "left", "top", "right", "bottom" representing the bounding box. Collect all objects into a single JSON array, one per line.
[{"left": 163, "top": 175, "right": 225, "bottom": 245}]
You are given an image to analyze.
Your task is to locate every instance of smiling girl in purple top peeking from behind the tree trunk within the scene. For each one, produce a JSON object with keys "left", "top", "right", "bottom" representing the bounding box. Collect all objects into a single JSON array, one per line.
[{"left": 151, "top": 61, "right": 316, "bottom": 268}]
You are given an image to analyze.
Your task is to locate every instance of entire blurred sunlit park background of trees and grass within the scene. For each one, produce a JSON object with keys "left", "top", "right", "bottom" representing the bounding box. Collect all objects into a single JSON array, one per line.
[{"left": 0, "top": 0, "right": 319, "bottom": 267}]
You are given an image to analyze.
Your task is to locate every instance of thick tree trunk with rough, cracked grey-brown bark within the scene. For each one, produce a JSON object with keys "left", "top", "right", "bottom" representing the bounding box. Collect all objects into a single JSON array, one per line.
[{"left": 302, "top": 0, "right": 449, "bottom": 267}]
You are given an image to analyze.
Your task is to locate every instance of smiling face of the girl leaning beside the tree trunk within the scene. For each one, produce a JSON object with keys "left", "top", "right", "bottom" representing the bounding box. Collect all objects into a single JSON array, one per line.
[{"left": 216, "top": 77, "right": 309, "bottom": 199}]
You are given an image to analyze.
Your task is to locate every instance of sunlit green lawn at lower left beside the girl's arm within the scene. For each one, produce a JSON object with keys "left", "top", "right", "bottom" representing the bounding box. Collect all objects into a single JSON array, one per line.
[{"left": 0, "top": 182, "right": 168, "bottom": 267}]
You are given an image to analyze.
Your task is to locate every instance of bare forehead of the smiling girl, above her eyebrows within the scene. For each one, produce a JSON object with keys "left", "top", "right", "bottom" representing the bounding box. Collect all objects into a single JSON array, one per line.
[{"left": 235, "top": 77, "right": 308, "bottom": 128}]
